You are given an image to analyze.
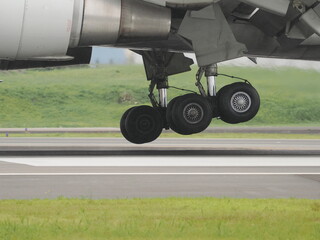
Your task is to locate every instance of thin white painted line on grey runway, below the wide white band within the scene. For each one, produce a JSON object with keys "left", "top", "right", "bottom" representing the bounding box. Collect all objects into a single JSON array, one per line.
[{"left": 0, "top": 172, "right": 320, "bottom": 177}]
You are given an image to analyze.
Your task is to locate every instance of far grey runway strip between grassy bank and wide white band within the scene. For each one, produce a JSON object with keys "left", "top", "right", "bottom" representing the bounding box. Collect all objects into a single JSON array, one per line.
[{"left": 0, "top": 137, "right": 320, "bottom": 156}]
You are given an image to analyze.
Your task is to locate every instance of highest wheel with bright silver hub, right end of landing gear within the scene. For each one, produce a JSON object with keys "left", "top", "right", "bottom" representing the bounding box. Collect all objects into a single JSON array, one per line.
[{"left": 218, "top": 83, "right": 260, "bottom": 124}]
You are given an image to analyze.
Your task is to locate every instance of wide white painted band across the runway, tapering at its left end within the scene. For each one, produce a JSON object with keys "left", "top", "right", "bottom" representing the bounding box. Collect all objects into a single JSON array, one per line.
[{"left": 0, "top": 156, "right": 320, "bottom": 167}]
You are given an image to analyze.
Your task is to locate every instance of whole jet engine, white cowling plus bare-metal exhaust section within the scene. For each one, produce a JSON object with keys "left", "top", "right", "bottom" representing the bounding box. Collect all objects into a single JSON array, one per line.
[{"left": 0, "top": 0, "right": 171, "bottom": 61}]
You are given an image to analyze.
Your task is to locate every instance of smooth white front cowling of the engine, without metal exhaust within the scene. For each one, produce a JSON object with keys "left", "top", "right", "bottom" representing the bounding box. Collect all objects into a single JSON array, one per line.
[{"left": 0, "top": 0, "right": 74, "bottom": 60}]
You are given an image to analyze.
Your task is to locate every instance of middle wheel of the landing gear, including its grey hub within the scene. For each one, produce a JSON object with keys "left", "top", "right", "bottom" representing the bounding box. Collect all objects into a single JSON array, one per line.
[{"left": 172, "top": 94, "right": 213, "bottom": 134}]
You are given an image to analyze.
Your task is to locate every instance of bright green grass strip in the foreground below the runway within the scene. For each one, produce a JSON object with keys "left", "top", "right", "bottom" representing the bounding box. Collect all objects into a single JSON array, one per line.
[{"left": 0, "top": 198, "right": 320, "bottom": 240}]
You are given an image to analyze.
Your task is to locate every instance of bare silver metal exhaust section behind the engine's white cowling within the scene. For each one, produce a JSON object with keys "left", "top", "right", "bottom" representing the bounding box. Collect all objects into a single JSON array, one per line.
[{"left": 73, "top": 0, "right": 171, "bottom": 46}]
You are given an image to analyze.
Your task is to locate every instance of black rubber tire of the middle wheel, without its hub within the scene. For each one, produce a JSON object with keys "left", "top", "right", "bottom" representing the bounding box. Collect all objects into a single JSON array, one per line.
[{"left": 172, "top": 94, "right": 213, "bottom": 135}]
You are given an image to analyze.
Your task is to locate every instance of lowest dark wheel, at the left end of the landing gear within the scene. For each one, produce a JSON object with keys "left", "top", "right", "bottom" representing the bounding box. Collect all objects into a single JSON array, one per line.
[{"left": 125, "top": 106, "right": 163, "bottom": 144}]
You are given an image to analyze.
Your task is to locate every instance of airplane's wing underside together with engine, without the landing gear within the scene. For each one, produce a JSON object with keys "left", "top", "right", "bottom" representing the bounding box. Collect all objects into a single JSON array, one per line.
[{"left": 0, "top": 0, "right": 320, "bottom": 69}]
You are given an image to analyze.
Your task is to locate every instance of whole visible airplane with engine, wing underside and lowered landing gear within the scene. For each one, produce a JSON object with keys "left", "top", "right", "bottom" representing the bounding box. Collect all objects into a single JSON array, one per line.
[{"left": 0, "top": 0, "right": 320, "bottom": 144}]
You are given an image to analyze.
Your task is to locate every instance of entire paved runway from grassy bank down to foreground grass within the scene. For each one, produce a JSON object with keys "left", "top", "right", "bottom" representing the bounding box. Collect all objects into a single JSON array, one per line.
[{"left": 0, "top": 138, "right": 320, "bottom": 199}]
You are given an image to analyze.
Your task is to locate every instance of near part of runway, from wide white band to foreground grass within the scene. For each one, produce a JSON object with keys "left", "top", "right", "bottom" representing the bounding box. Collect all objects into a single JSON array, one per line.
[{"left": 0, "top": 157, "right": 320, "bottom": 199}]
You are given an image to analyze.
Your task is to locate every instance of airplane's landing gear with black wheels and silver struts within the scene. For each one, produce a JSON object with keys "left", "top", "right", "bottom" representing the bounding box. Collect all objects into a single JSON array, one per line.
[{"left": 120, "top": 62, "right": 260, "bottom": 144}]
